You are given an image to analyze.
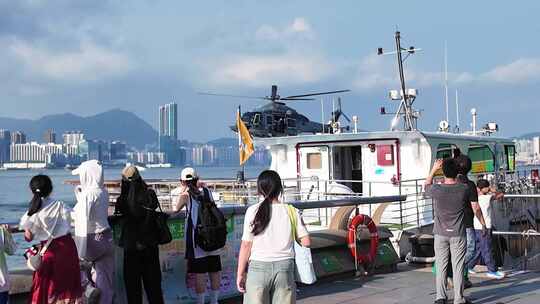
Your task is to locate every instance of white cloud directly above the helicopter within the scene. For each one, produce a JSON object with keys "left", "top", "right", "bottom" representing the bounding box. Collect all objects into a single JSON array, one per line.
[{"left": 198, "top": 17, "right": 334, "bottom": 87}]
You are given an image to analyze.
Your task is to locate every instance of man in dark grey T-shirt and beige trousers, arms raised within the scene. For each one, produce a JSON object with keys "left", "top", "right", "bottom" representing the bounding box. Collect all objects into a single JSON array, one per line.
[{"left": 425, "top": 158, "right": 470, "bottom": 304}]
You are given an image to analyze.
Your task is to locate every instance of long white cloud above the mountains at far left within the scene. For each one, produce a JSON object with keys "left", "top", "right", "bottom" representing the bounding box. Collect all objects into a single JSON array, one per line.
[{"left": 9, "top": 40, "right": 132, "bottom": 82}]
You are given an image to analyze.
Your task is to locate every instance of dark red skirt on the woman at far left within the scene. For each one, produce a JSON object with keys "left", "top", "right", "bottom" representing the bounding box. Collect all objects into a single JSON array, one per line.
[{"left": 30, "top": 234, "right": 83, "bottom": 304}]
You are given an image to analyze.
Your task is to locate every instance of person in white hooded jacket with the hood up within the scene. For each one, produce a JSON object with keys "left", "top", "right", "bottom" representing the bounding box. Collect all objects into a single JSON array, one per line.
[{"left": 72, "top": 160, "right": 114, "bottom": 304}]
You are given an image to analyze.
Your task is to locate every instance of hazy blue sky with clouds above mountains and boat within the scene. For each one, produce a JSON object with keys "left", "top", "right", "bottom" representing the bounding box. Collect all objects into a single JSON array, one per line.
[{"left": 0, "top": 0, "right": 540, "bottom": 141}]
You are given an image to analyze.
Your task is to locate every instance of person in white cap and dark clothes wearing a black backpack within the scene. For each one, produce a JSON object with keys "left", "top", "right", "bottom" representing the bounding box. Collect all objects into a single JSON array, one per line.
[{"left": 173, "top": 167, "right": 221, "bottom": 304}]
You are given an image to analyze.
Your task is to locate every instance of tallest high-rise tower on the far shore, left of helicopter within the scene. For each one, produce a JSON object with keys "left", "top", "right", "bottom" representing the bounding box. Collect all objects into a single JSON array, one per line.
[{"left": 158, "top": 103, "right": 184, "bottom": 166}]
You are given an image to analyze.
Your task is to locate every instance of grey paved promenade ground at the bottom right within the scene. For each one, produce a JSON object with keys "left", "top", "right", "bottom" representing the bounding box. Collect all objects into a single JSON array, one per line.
[{"left": 227, "top": 263, "right": 540, "bottom": 304}]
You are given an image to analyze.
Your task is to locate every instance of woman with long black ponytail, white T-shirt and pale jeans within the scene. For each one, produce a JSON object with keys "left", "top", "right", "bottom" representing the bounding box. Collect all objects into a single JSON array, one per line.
[{"left": 236, "top": 170, "right": 311, "bottom": 304}]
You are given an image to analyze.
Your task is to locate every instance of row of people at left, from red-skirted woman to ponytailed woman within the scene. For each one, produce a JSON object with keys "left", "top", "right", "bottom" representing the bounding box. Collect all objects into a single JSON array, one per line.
[{"left": 0, "top": 164, "right": 310, "bottom": 304}]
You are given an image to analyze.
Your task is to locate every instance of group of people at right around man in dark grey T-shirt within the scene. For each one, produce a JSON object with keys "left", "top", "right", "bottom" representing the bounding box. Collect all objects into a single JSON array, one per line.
[{"left": 425, "top": 154, "right": 504, "bottom": 304}]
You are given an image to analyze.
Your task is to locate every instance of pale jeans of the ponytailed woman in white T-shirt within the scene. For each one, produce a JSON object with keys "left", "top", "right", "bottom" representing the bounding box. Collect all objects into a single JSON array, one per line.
[{"left": 244, "top": 259, "right": 296, "bottom": 304}]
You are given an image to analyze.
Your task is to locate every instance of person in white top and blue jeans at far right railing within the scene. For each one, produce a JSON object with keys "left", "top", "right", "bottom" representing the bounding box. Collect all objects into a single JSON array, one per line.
[{"left": 467, "top": 179, "right": 505, "bottom": 279}]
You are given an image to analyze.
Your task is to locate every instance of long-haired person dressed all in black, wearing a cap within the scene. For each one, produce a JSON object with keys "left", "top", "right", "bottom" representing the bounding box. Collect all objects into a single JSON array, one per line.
[{"left": 115, "top": 166, "right": 163, "bottom": 304}]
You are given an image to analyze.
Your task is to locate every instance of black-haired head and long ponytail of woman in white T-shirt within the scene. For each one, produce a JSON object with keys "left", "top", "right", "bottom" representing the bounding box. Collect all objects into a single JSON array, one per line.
[{"left": 251, "top": 170, "right": 283, "bottom": 235}]
